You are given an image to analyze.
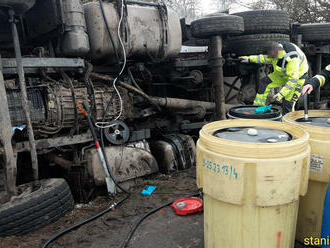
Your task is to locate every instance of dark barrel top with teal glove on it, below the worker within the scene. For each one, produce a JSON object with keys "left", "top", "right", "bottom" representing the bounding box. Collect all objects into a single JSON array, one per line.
[{"left": 228, "top": 105, "right": 281, "bottom": 119}]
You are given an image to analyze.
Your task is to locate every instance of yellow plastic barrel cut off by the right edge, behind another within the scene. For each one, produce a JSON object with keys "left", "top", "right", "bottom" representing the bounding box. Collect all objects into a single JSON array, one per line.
[{"left": 283, "top": 110, "right": 330, "bottom": 242}]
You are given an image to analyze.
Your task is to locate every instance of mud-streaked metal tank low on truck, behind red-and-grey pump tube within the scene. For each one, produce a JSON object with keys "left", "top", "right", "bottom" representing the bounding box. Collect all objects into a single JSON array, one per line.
[{"left": 86, "top": 142, "right": 159, "bottom": 185}]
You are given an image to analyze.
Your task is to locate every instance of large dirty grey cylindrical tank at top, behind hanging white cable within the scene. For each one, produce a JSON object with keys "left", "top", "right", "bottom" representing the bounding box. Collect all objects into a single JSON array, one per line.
[{"left": 84, "top": 2, "right": 182, "bottom": 62}]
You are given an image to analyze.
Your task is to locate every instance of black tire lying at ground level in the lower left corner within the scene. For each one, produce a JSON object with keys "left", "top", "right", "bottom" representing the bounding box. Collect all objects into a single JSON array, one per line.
[{"left": 0, "top": 179, "right": 74, "bottom": 237}]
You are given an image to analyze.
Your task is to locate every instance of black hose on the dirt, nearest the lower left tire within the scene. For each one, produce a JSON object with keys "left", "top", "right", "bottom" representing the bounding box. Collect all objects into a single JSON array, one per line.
[{"left": 42, "top": 195, "right": 129, "bottom": 248}]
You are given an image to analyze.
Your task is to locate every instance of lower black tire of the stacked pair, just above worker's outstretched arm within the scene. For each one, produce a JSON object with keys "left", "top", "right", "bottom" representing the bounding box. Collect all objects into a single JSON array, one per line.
[{"left": 224, "top": 34, "right": 290, "bottom": 56}]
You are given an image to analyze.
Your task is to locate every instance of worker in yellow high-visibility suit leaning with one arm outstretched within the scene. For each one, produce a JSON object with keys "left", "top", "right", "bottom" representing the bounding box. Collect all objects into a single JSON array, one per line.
[{"left": 240, "top": 42, "right": 309, "bottom": 114}]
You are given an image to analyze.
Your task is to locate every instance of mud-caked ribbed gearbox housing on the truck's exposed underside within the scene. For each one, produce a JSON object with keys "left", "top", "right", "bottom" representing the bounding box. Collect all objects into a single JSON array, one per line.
[{"left": 7, "top": 84, "right": 133, "bottom": 134}]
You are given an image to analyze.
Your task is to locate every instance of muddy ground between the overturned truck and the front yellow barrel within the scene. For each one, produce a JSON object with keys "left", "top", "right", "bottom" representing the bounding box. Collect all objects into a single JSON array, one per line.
[{"left": 0, "top": 168, "right": 307, "bottom": 248}]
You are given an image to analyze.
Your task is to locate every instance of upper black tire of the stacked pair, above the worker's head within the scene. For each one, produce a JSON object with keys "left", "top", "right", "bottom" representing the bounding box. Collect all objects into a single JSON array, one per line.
[{"left": 234, "top": 10, "right": 290, "bottom": 34}]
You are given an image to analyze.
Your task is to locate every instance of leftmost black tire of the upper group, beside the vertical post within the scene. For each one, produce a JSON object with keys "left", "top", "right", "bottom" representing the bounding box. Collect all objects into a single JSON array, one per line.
[{"left": 191, "top": 14, "right": 244, "bottom": 38}]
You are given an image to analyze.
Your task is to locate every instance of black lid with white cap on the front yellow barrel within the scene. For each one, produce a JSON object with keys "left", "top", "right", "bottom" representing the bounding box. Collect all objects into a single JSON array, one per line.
[{"left": 213, "top": 127, "right": 293, "bottom": 143}]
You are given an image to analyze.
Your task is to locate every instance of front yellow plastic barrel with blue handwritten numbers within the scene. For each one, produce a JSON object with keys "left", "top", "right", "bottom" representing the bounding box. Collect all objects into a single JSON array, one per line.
[{"left": 197, "top": 120, "right": 310, "bottom": 248}]
